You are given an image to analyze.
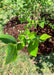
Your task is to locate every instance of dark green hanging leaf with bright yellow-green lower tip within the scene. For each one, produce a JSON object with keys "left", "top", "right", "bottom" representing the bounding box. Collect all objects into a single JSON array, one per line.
[{"left": 27, "top": 39, "right": 39, "bottom": 56}]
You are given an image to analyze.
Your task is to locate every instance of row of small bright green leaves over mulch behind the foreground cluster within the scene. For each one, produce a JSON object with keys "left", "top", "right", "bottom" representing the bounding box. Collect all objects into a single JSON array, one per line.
[{"left": 25, "top": 17, "right": 46, "bottom": 28}]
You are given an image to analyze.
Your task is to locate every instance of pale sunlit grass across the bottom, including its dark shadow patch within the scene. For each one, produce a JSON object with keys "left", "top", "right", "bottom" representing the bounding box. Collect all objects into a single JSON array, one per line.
[{"left": 0, "top": 26, "right": 54, "bottom": 75}]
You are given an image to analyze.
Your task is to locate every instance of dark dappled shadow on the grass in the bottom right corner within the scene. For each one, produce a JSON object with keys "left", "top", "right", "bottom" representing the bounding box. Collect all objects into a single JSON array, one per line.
[{"left": 30, "top": 53, "right": 54, "bottom": 75}]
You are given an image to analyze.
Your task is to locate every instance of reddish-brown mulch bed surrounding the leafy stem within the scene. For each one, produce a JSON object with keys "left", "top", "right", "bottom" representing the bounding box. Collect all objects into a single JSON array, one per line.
[{"left": 4, "top": 16, "right": 54, "bottom": 54}]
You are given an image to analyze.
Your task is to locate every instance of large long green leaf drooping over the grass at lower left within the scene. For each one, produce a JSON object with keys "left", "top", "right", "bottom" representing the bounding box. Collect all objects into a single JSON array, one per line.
[{"left": 5, "top": 43, "right": 17, "bottom": 65}]
